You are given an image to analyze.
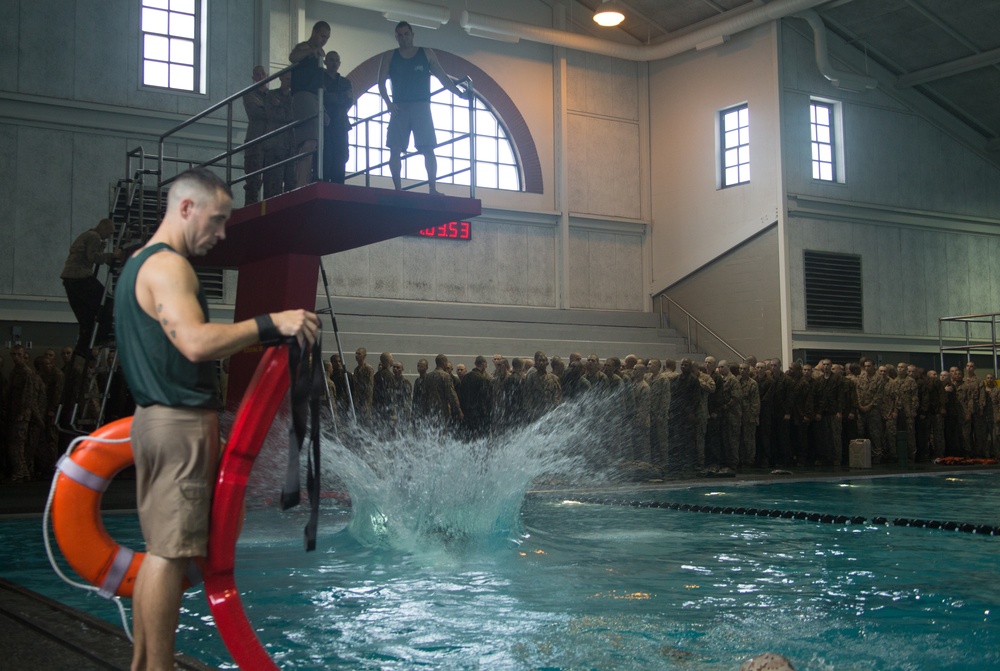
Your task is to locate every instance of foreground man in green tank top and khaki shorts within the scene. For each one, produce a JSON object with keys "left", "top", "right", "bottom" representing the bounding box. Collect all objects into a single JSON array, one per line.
[{"left": 115, "top": 168, "right": 319, "bottom": 671}]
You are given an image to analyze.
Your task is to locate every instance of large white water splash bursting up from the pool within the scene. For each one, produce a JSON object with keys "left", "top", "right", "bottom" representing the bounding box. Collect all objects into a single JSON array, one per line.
[{"left": 245, "top": 395, "right": 618, "bottom": 557}]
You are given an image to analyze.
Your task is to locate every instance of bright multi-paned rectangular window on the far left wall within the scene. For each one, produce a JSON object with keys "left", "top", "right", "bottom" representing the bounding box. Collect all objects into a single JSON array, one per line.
[{"left": 141, "top": 0, "right": 206, "bottom": 93}]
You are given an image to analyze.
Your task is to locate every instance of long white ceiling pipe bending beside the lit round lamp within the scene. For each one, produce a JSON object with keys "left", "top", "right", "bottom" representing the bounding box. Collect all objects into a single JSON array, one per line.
[{"left": 460, "top": 0, "right": 828, "bottom": 61}]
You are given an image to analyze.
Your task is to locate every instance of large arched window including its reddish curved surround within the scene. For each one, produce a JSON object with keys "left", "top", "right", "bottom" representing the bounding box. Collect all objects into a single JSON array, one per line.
[{"left": 347, "top": 49, "right": 543, "bottom": 193}]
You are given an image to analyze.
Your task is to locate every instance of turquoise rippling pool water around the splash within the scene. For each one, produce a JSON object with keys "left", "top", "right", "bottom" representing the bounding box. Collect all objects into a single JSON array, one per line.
[{"left": 7, "top": 471, "right": 1000, "bottom": 671}]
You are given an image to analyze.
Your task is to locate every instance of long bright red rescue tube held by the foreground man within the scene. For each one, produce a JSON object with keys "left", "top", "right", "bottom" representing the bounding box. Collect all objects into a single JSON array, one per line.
[{"left": 202, "top": 346, "right": 289, "bottom": 671}]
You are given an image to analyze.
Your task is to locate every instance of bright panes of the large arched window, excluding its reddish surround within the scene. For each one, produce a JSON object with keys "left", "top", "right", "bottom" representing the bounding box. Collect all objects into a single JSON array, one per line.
[{"left": 347, "top": 80, "right": 523, "bottom": 191}]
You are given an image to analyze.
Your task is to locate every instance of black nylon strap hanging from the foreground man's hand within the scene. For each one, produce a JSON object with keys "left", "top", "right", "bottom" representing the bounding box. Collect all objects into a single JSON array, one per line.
[{"left": 281, "top": 329, "right": 325, "bottom": 552}]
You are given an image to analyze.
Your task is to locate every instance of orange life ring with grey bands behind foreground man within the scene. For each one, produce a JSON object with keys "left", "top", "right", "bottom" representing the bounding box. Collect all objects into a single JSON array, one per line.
[{"left": 52, "top": 417, "right": 200, "bottom": 598}]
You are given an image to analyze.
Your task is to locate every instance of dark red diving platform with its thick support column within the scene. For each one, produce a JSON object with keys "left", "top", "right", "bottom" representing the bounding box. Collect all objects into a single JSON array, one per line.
[{"left": 192, "top": 182, "right": 482, "bottom": 408}]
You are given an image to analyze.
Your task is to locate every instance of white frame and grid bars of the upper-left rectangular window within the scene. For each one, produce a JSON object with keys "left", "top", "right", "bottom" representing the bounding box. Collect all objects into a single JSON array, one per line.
[{"left": 138, "top": 0, "right": 208, "bottom": 96}]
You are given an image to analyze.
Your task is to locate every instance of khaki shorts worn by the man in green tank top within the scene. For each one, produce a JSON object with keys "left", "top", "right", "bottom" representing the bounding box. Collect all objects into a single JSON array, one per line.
[{"left": 132, "top": 405, "right": 219, "bottom": 559}]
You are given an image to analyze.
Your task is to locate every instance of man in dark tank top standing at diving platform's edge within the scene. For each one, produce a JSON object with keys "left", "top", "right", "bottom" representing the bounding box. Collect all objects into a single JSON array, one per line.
[{"left": 378, "top": 21, "right": 471, "bottom": 193}]
